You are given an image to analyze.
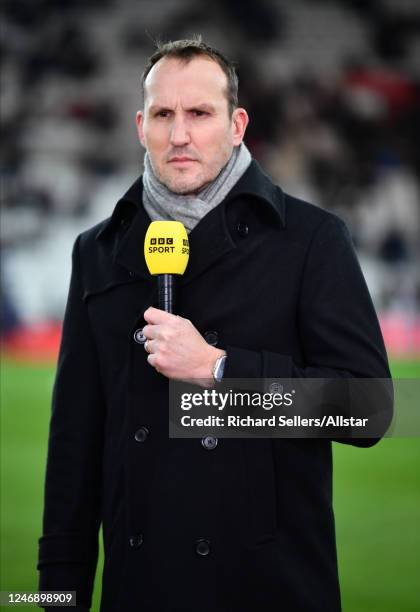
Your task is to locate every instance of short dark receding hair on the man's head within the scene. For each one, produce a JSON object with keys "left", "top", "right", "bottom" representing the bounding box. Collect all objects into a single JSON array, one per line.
[{"left": 141, "top": 35, "right": 238, "bottom": 115}]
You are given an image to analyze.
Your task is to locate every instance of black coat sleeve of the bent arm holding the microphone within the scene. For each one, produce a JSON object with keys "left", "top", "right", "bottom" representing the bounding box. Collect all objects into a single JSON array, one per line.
[{"left": 224, "top": 215, "right": 392, "bottom": 446}]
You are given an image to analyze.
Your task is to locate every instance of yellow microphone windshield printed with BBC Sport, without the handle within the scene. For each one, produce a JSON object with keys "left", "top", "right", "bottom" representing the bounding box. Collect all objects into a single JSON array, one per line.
[{"left": 144, "top": 221, "right": 190, "bottom": 275}]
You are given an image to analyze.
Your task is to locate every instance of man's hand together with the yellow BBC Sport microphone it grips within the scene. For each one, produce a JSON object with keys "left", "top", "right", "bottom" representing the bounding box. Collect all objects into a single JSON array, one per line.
[{"left": 143, "top": 221, "right": 225, "bottom": 386}]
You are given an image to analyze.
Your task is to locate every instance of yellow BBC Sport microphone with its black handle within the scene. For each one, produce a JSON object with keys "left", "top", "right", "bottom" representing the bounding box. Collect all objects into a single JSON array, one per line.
[{"left": 144, "top": 221, "right": 190, "bottom": 312}]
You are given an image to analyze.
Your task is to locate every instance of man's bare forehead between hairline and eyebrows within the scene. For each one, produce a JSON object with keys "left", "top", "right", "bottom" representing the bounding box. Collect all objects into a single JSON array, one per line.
[{"left": 144, "top": 56, "right": 227, "bottom": 104}]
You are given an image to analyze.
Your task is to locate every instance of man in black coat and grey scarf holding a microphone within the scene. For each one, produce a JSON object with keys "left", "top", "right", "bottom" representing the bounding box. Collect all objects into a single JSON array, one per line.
[{"left": 39, "top": 39, "right": 389, "bottom": 612}]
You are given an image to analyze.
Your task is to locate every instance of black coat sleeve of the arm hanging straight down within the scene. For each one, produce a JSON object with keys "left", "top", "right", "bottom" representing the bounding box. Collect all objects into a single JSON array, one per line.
[{"left": 38, "top": 237, "right": 105, "bottom": 609}]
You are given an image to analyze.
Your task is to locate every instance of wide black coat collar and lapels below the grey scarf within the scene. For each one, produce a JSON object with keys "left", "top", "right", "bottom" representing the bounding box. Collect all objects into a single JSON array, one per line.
[{"left": 96, "top": 160, "right": 285, "bottom": 284}]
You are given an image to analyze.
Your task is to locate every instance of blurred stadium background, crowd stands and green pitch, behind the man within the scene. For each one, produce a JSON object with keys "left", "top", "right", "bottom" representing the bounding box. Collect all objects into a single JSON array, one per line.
[{"left": 0, "top": 0, "right": 420, "bottom": 612}]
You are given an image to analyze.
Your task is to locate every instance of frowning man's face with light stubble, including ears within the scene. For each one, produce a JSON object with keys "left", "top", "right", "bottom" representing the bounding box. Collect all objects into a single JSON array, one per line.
[{"left": 137, "top": 57, "right": 248, "bottom": 194}]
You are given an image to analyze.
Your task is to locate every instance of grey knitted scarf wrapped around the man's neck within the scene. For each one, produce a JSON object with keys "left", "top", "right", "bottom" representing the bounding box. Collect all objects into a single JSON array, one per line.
[{"left": 143, "top": 143, "right": 251, "bottom": 233}]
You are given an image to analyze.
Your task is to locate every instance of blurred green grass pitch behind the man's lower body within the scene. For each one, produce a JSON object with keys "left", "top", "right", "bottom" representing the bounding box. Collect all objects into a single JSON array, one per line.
[{"left": 0, "top": 362, "right": 420, "bottom": 612}]
